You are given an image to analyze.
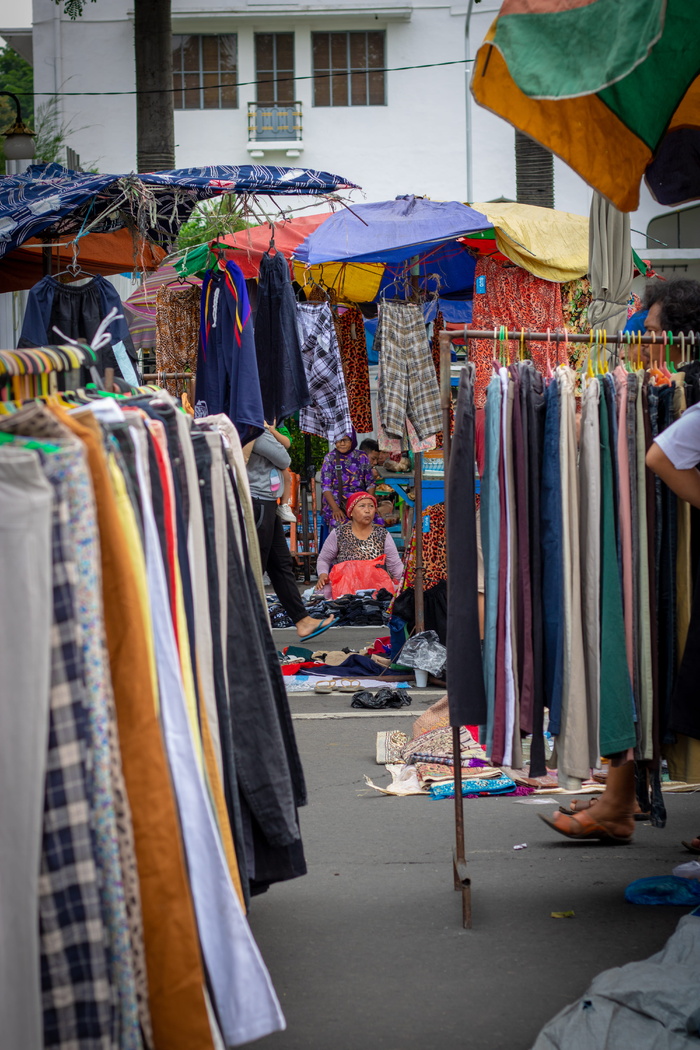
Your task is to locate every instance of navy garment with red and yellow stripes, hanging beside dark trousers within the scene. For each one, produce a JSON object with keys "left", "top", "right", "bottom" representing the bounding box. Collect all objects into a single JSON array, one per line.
[{"left": 194, "top": 261, "right": 264, "bottom": 444}]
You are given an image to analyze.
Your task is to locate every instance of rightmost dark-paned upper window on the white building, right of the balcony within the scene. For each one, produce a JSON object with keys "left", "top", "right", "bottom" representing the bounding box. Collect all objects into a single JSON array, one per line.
[{"left": 312, "top": 33, "right": 386, "bottom": 106}]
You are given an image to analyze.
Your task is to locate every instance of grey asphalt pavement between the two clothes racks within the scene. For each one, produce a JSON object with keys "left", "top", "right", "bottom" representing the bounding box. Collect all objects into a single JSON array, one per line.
[{"left": 250, "top": 688, "right": 700, "bottom": 1050}]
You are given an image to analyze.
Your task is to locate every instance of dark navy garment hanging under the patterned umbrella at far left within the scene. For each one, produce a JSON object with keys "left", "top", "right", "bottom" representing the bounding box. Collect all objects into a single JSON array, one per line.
[{"left": 18, "top": 275, "right": 140, "bottom": 384}]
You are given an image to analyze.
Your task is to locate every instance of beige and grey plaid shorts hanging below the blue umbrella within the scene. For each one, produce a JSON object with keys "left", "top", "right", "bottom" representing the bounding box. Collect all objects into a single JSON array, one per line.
[{"left": 375, "top": 302, "right": 442, "bottom": 441}]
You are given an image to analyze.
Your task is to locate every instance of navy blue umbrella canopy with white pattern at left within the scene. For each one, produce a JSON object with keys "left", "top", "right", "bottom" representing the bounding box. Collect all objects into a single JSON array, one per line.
[{"left": 0, "top": 164, "right": 358, "bottom": 258}]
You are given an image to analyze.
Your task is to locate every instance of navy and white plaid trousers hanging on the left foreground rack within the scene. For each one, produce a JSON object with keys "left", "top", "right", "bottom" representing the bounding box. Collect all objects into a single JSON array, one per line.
[{"left": 39, "top": 483, "right": 119, "bottom": 1050}]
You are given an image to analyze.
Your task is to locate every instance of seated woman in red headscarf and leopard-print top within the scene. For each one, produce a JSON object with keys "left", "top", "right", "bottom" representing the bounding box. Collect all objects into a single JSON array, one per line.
[{"left": 316, "top": 492, "right": 403, "bottom": 599}]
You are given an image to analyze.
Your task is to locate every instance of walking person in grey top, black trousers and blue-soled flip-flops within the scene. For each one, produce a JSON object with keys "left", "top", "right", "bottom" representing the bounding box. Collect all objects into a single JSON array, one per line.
[{"left": 248, "top": 426, "right": 339, "bottom": 641}]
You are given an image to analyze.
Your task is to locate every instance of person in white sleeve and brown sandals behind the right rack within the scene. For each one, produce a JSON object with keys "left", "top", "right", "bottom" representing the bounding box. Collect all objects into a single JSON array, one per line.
[{"left": 538, "top": 277, "right": 700, "bottom": 849}]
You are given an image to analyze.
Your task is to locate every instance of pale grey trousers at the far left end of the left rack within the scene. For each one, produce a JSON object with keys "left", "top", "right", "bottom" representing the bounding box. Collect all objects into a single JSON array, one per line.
[{"left": 0, "top": 448, "right": 52, "bottom": 1047}]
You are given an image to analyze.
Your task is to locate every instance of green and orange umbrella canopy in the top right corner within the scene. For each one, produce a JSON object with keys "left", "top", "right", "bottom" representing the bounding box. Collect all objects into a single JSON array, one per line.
[{"left": 471, "top": 0, "right": 700, "bottom": 211}]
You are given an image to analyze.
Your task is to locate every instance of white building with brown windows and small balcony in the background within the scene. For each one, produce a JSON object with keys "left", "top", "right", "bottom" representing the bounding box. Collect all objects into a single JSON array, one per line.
[{"left": 0, "top": 0, "right": 696, "bottom": 266}]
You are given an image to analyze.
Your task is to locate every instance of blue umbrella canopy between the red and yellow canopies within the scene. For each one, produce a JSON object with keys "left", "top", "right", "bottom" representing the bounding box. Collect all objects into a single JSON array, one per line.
[{"left": 294, "top": 196, "right": 493, "bottom": 266}]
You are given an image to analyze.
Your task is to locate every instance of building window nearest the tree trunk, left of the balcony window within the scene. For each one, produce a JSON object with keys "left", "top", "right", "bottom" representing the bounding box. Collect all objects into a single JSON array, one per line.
[{"left": 172, "top": 33, "right": 238, "bottom": 109}]
